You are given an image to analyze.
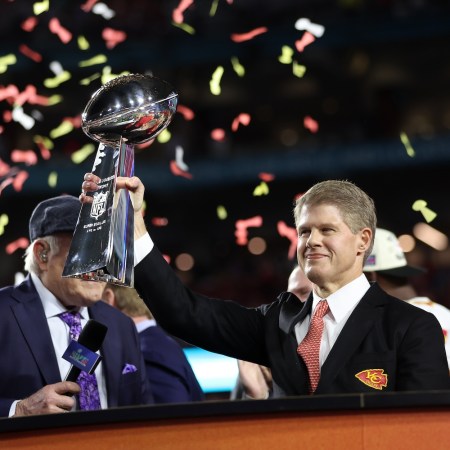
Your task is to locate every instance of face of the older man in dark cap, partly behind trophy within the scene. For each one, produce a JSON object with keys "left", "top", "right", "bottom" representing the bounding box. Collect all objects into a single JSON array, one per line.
[{"left": 41, "top": 233, "right": 106, "bottom": 307}]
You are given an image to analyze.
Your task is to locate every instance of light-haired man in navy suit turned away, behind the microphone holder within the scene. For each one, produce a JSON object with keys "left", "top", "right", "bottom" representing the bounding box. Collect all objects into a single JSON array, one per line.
[{"left": 102, "top": 283, "right": 205, "bottom": 403}]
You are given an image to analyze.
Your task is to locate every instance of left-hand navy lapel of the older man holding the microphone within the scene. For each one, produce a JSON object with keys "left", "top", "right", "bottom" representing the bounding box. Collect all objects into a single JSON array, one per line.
[{"left": 11, "top": 278, "right": 61, "bottom": 384}]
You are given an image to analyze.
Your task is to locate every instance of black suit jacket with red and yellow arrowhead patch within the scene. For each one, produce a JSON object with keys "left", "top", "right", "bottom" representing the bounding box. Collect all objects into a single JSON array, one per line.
[{"left": 135, "top": 248, "right": 450, "bottom": 396}]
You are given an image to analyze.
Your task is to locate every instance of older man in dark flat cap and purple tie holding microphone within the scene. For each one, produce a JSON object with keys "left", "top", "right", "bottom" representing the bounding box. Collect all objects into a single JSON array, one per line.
[{"left": 0, "top": 195, "right": 152, "bottom": 416}]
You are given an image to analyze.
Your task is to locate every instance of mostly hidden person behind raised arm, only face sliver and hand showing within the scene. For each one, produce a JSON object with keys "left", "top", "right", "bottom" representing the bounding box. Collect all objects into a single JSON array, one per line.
[{"left": 230, "top": 264, "right": 313, "bottom": 400}]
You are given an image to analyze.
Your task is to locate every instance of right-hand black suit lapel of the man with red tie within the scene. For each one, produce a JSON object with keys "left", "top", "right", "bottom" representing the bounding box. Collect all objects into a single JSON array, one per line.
[{"left": 316, "top": 285, "right": 386, "bottom": 394}]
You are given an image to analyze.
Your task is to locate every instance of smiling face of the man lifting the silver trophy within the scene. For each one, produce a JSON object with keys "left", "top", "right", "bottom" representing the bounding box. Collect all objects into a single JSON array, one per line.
[{"left": 297, "top": 204, "right": 371, "bottom": 295}]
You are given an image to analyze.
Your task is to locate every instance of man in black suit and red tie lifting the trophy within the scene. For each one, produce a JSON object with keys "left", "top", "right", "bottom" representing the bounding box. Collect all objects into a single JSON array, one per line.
[{"left": 80, "top": 178, "right": 449, "bottom": 397}]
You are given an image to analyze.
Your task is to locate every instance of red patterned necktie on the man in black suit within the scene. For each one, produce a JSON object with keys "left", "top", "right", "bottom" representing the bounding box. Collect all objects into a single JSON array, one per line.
[{"left": 297, "top": 300, "right": 329, "bottom": 394}]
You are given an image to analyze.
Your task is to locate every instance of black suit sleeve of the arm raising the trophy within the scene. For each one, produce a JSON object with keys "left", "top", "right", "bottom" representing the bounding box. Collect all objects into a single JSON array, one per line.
[{"left": 134, "top": 244, "right": 268, "bottom": 365}]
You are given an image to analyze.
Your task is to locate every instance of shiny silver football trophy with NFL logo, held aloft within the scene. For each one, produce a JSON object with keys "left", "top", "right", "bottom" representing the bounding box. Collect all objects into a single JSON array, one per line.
[{"left": 62, "top": 74, "right": 178, "bottom": 286}]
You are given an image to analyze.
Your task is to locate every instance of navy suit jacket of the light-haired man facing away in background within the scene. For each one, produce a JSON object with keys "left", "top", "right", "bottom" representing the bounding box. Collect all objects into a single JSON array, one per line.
[{"left": 139, "top": 326, "right": 204, "bottom": 403}]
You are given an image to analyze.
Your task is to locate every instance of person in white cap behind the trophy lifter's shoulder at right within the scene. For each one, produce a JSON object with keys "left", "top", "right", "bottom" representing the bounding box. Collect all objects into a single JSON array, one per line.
[{"left": 364, "top": 228, "right": 450, "bottom": 366}]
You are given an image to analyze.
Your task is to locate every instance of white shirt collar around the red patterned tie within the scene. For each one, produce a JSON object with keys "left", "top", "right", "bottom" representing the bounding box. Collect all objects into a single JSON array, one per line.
[{"left": 312, "top": 274, "right": 370, "bottom": 323}]
